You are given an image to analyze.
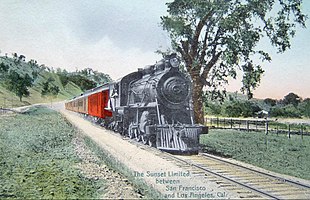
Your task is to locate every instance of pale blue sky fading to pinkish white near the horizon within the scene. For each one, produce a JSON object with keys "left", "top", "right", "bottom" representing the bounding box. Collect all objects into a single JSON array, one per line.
[{"left": 0, "top": 0, "right": 310, "bottom": 99}]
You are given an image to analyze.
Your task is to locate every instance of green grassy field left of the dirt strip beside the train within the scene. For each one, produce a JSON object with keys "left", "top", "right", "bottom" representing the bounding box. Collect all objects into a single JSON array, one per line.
[{"left": 0, "top": 108, "right": 102, "bottom": 199}]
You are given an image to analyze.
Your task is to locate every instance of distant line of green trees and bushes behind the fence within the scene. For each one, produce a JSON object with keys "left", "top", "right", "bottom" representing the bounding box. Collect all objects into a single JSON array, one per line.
[{"left": 204, "top": 92, "right": 310, "bottom": 118}]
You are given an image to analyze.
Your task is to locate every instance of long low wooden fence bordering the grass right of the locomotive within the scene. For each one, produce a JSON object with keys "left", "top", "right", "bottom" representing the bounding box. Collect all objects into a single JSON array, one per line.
[{"left": 206, "top": 118, "right": 310, "bottom": 137}]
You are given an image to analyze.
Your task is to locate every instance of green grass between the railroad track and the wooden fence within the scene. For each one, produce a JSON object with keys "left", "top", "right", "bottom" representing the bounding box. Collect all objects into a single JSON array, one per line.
[{"left": 200, "top": 129, "right": 310, "bottom": 180}]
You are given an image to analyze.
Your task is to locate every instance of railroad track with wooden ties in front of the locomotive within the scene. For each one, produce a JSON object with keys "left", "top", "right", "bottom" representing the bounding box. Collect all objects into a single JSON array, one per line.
[{"left": 170, "top": 153, "right": 310, "bottom": 199}]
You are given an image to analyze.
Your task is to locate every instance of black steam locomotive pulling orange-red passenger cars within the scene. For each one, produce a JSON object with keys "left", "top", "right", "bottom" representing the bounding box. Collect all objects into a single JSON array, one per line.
[{"left": 65, "top": 54, "right": 208, "bottom": 154}]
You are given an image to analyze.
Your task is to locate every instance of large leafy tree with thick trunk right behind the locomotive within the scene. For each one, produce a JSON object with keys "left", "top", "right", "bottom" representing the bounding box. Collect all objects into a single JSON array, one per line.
[{"left": 161, "top": 0, "right": 306, "bottom": 123}]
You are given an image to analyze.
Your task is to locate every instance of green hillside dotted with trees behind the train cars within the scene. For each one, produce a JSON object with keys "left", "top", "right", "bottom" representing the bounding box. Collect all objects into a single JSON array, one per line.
[{"left": 0, "top": 54, "right": 111, "bottom": 107}]
